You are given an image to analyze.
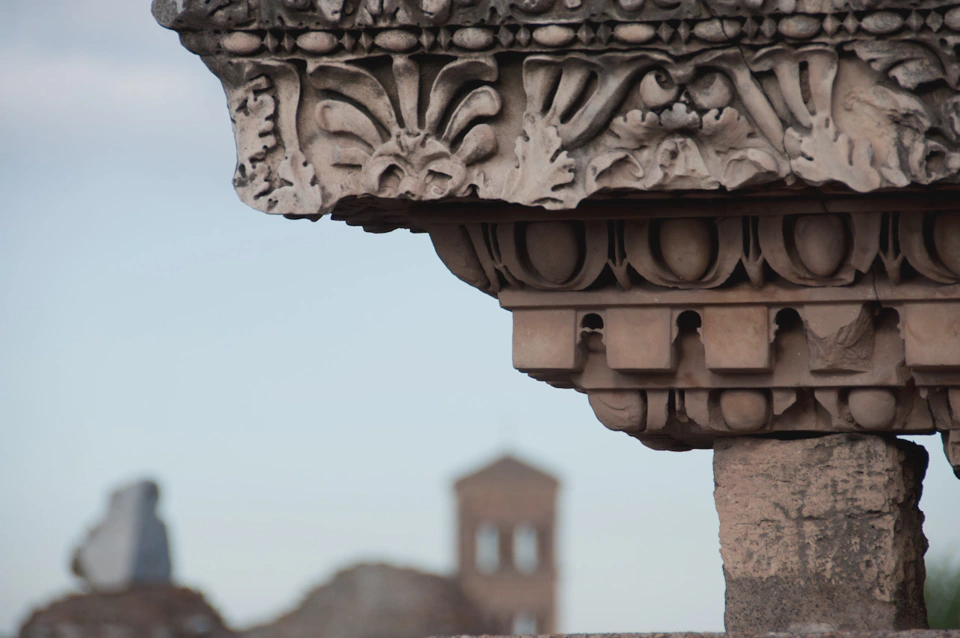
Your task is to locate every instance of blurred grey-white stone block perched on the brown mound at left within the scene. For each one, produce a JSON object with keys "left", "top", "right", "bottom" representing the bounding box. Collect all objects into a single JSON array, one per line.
[{"left": 72, "top": 481, "right": 171, "bottom": 592}]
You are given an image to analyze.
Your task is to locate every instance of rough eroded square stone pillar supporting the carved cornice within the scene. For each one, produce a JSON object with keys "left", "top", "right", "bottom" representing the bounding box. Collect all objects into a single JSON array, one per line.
[{"left": 714, "top": 434, "right": 927, "bottom": 631}]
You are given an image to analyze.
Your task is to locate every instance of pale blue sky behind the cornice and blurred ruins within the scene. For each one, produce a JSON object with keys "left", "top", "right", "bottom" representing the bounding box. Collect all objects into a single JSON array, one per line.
[{"left": 0, "top": 0, "right": 960, "bottom": 633}]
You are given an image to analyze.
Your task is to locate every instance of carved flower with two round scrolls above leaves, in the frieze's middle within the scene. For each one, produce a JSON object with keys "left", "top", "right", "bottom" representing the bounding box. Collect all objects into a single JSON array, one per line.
[{"left": 587, "top": 51, "right": 789, "bottom": 194}]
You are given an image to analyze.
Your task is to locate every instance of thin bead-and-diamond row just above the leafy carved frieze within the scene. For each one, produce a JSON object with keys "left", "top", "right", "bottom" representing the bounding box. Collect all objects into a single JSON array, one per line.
[{"left": 195, "top": 10, "right": 960, "bottom": 57}]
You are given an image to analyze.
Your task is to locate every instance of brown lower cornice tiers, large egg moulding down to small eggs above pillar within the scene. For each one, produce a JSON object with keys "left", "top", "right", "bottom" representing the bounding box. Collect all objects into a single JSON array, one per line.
[{"left": 420, "top": 210, "right": 960, "bottom": 467}]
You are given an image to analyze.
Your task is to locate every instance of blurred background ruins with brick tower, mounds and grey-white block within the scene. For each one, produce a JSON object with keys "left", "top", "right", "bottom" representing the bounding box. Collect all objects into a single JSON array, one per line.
[{"left": 20, "top": 455, "right": 559, "bottom": 638}]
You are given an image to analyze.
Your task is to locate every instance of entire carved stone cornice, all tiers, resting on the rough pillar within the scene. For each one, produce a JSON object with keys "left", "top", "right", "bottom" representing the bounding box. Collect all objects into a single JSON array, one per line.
[{"left": 154, "top": 0, "right": 960, "bottom": 472}]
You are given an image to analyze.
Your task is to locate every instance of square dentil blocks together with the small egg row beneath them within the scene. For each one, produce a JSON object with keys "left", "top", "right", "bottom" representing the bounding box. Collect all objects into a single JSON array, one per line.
[{"left": 501, "top": 300, "right": 960, "bottom": 466}]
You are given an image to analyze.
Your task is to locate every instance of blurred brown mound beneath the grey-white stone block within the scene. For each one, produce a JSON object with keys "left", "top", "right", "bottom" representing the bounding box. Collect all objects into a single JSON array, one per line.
[{"left": 19, "top": 585, "right": 234, "bottom": 638}]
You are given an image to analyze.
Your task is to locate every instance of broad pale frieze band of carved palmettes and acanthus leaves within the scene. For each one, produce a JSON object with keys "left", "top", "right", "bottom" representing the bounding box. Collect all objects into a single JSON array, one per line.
[{"left": 207, "top": 43, "right": 960, "bottom": 217}]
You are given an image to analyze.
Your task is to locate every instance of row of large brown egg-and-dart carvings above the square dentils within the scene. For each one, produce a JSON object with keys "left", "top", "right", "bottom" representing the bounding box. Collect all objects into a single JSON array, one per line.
[{"left": 428, "top": 211, "right": 960, "bottom": 294}]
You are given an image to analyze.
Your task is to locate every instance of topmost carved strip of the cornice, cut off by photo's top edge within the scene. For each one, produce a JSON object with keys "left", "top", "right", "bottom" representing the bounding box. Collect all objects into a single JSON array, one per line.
[{"left": 153, "top": 0, "right": 960, "bottom": 30}]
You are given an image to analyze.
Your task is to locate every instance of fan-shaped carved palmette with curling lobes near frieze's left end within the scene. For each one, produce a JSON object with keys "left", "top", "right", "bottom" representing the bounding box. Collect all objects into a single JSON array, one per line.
[{"left": 308, "top": 57, "right": 502, "bottom": 209}]
